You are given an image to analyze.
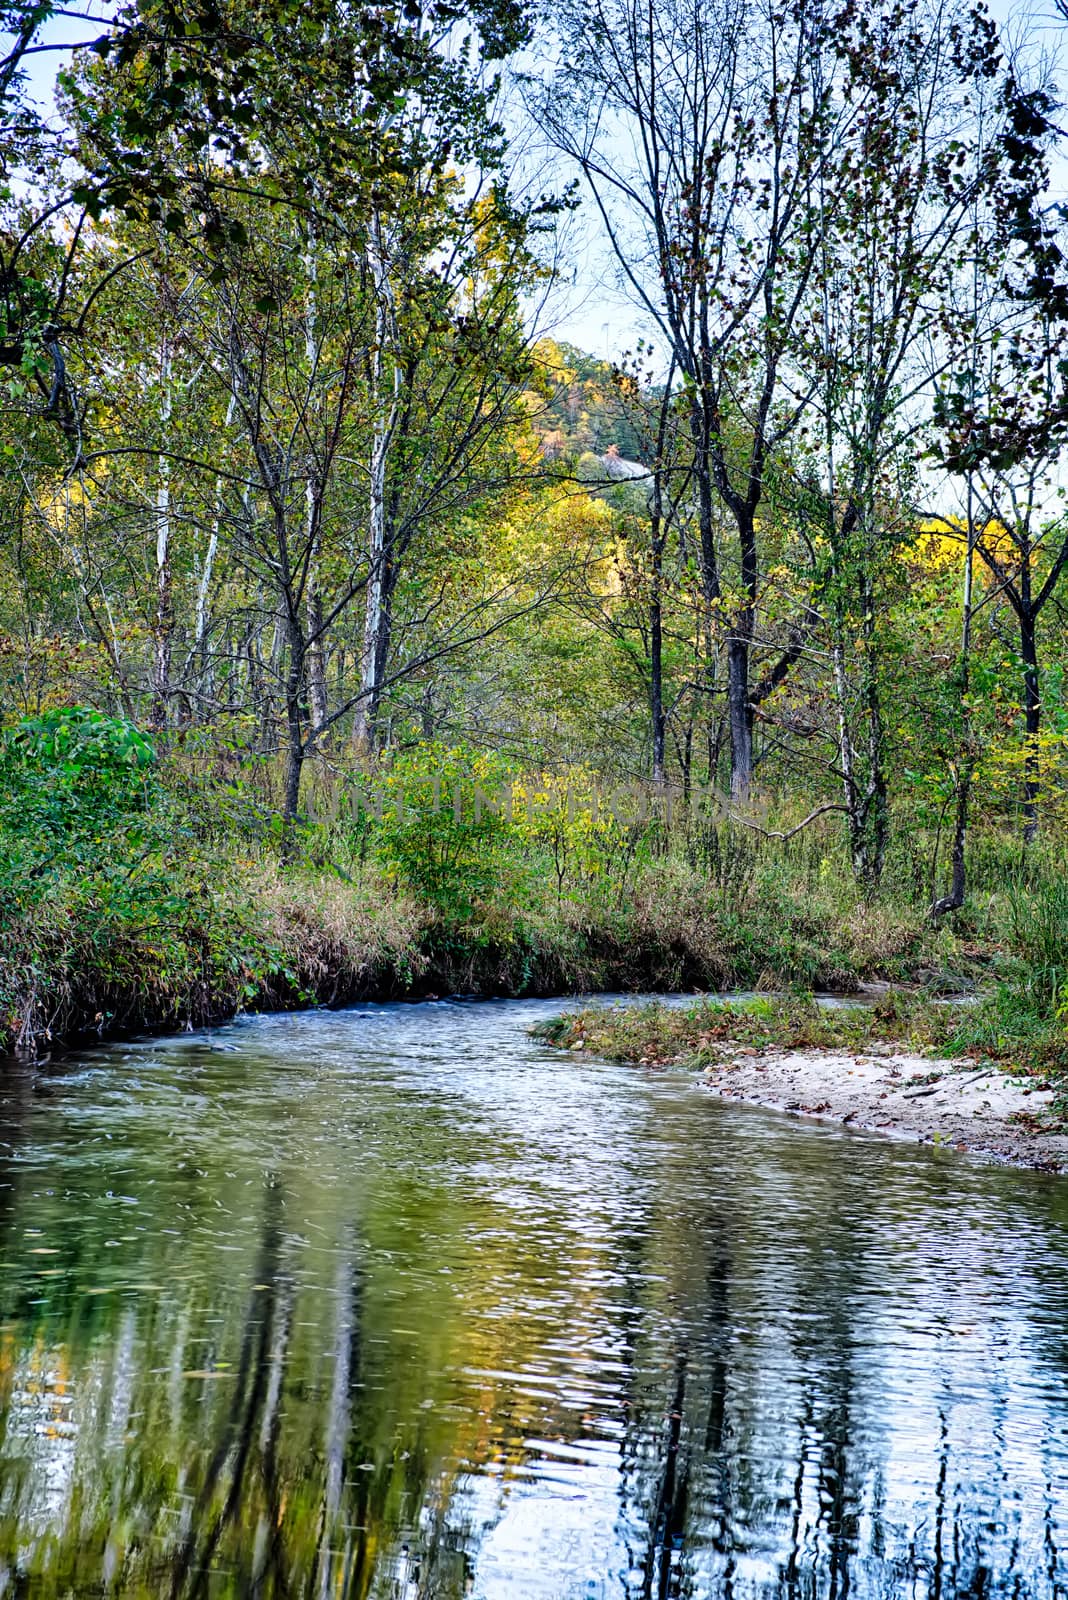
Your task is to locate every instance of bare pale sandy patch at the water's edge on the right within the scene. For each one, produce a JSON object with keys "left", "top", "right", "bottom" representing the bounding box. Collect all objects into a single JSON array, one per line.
[{"left": 702, "top": 1045, "right": 1068, "bottom": 1171}]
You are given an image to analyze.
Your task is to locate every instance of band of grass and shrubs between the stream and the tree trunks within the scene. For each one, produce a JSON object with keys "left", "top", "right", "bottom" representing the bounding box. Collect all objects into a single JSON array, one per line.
[{"left": 0, "top": 709, "right": 1068, "bottom": 1070}]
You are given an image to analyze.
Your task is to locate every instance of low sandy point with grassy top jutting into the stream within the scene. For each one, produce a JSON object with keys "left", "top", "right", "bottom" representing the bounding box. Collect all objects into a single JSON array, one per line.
[{"left": 536, "top": 990, "right": 1068, "bottom": 1171}]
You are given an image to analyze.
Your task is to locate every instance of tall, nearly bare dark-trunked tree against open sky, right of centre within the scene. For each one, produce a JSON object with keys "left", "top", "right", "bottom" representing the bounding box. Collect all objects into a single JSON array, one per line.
[{"left": 539, "top": 0, "right": 855, "bottom": 800}]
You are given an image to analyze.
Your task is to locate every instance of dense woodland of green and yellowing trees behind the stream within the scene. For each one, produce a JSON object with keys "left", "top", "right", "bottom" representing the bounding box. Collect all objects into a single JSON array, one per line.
[{"left": 0, "top": 0, "right": 1068, "bottom": 1059}]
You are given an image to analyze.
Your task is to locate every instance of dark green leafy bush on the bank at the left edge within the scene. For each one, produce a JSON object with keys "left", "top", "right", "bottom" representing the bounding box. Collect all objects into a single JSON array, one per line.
[{"left": 0, "top": 706, "right": 294, "bottom": 1043}]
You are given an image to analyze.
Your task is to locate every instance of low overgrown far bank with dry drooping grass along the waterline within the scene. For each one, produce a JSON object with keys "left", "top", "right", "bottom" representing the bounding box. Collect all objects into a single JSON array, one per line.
[{"left": 0, "top": 866, "right": 855, "bottom": 1056}]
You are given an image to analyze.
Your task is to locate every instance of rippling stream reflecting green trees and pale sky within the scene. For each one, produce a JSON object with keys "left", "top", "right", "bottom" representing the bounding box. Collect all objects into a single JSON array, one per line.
[{"left": 0, "top": 1002, "right": 1068, "bottom": 1600}]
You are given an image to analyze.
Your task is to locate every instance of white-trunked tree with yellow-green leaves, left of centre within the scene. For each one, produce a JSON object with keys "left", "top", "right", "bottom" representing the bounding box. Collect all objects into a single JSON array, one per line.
[{"left": 353, "top": 176, "right": 553, "bottom": 752}]
